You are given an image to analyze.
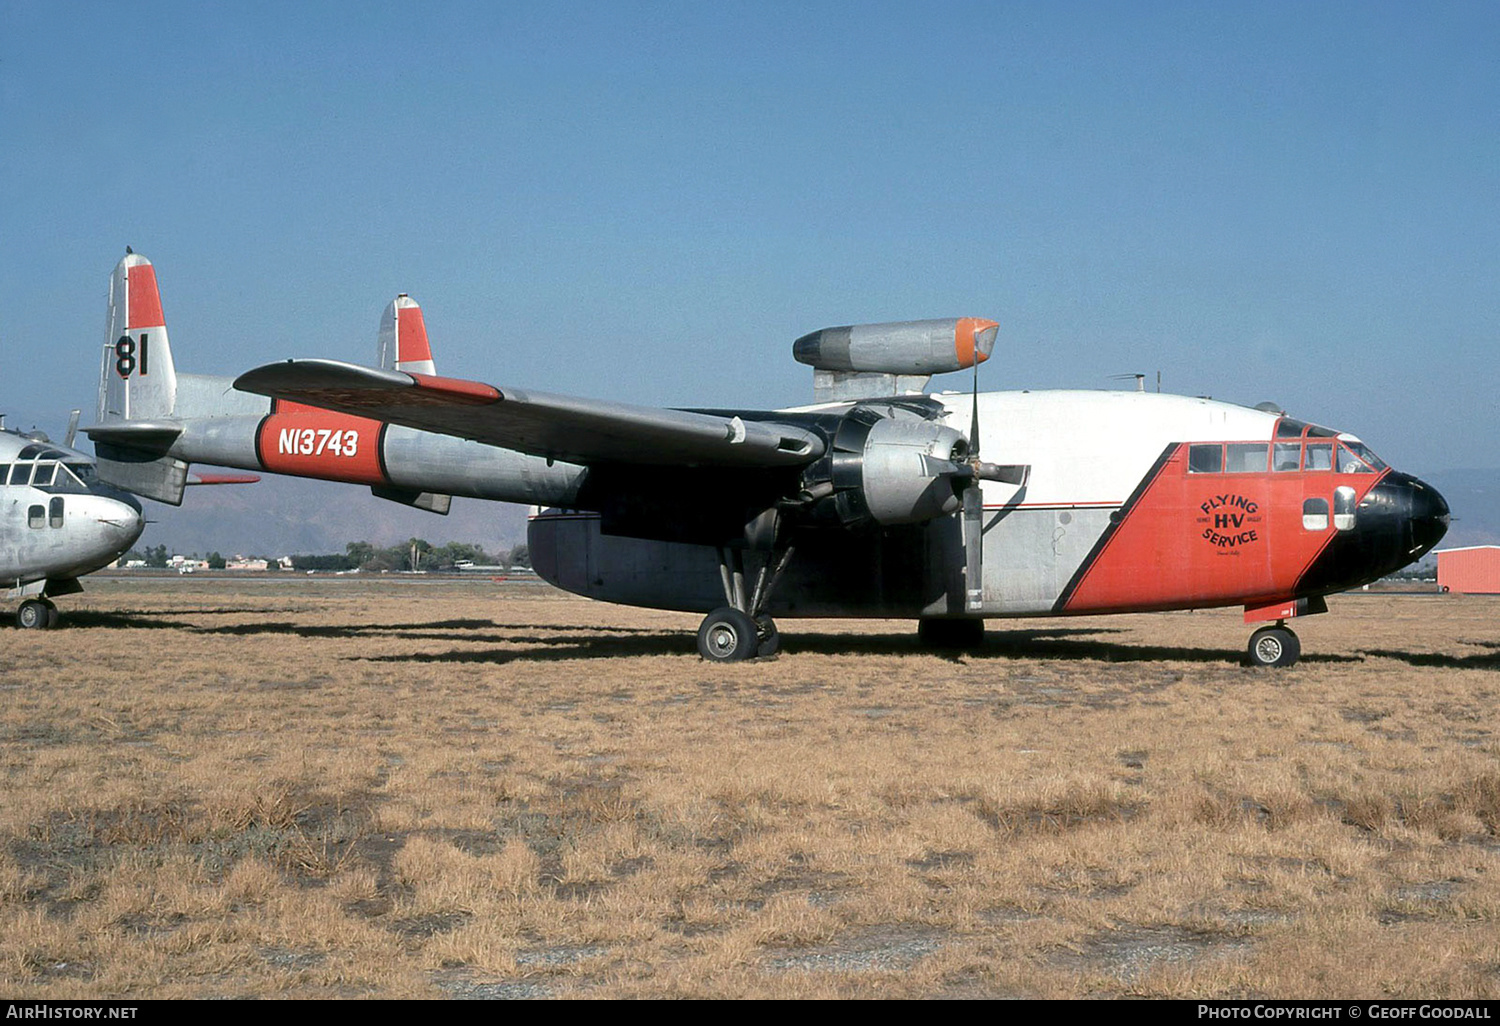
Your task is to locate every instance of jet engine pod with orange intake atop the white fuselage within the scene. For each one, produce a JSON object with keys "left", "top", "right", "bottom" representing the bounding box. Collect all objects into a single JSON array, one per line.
[{"left": 792, "top": 317, "right": 999, "bottom": 375}]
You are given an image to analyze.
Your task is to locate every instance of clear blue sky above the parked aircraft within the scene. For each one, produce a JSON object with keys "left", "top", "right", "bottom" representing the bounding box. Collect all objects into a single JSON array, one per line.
[{"left": 0, "top": 0, "right": 1500, "bottom": 473}]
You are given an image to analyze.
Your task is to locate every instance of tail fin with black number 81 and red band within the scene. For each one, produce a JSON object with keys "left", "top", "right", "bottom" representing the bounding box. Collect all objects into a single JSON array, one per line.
[{"left": 99, "top": 251, "right": 177, "bottom": 425}]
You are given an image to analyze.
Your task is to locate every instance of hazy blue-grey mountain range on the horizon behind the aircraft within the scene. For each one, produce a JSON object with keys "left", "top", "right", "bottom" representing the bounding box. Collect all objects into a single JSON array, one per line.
[{"left": 140, "top": 468, "right": 1500, "bottom": 557}]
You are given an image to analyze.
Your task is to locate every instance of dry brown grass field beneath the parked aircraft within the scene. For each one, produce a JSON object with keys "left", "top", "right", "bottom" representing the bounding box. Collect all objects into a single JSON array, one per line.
[{"left": 0, "top": 579, "right": 1500, "bottom": 998}]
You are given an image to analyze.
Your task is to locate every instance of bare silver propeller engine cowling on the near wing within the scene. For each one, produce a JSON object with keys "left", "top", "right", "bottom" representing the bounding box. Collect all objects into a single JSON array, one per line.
[{"left": 804, "top": 407, "right": 969, "bottom": 527}]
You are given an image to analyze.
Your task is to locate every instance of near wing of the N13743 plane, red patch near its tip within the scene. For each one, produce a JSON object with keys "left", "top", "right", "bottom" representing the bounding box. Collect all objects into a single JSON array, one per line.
[{"left": 234, "top": 360, "right": 824, "bottom": 467}]
